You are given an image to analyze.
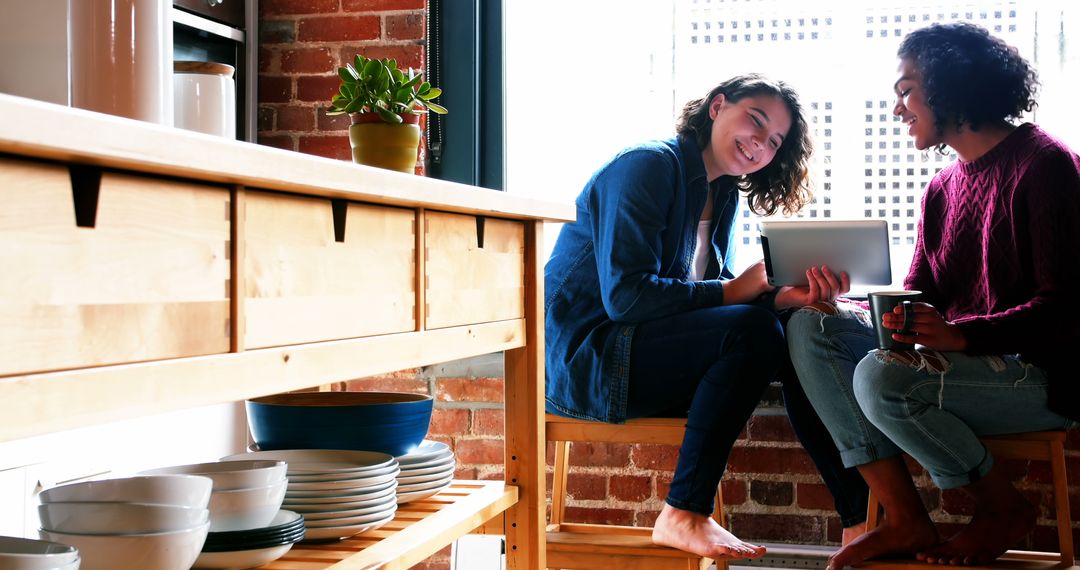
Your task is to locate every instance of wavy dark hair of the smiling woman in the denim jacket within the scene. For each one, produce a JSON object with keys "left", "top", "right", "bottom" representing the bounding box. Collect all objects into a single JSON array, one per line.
[{"left": 675, "top": 73, "right": 813, "bottom": 216}]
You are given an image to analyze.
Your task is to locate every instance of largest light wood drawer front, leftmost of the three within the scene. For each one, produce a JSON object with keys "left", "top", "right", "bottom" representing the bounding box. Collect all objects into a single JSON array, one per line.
[{"left": 0, "top": 159, "right": 230, "bottom": 375}]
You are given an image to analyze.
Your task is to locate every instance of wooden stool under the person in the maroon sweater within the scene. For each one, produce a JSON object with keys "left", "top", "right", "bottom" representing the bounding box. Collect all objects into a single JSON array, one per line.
[{"left": 860, "top": 431, "right": 1075, "bottom": 570}]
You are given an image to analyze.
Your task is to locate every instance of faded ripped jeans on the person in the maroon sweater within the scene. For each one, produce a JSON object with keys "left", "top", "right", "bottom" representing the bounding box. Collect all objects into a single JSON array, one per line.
[{"left": 787, "top": 304, "right": 1077, "bottom": 489}]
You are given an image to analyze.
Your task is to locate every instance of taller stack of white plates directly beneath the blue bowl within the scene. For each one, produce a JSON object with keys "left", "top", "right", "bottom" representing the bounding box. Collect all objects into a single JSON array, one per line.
[{"left": 222, "top": 449, "right": 400, "bottom": 541}]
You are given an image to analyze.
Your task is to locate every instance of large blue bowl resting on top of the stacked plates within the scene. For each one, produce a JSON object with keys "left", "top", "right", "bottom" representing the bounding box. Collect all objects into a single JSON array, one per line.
[{"left": 246, "top": 392, "right": 433, "bottom": 456}]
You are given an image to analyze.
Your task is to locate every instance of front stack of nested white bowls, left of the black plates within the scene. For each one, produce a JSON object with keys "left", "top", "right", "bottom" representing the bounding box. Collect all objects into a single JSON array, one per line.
[{"left": 38, "top": 475, "right": 212, "bottom": 570}]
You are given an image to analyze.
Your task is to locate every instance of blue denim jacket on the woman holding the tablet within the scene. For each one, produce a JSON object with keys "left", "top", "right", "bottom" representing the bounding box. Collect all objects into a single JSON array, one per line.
[{"left": 544, "top": 137, "right": 739, "bottom": 423}]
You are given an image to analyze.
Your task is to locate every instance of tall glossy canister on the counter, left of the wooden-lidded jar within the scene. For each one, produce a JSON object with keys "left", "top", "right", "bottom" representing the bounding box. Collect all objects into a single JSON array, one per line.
[{"left": 68, "top": 0, "right": 173, "bottom": 125}]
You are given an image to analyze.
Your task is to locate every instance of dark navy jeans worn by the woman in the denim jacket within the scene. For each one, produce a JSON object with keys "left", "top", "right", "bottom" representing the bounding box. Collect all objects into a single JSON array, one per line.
[{"left": 627, "top": 306, "right": 867, "bottom": 526}]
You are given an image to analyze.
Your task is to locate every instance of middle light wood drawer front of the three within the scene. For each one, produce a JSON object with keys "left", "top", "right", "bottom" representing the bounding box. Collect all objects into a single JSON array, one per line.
[{"left": 242, "top": 192, "right": 416, "bottom": 348}]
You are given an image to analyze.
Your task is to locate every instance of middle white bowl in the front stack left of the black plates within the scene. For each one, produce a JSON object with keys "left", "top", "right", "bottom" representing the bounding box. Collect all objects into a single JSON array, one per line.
[{"left": 38, "top": 502, "right": 210, "bottom": 534}]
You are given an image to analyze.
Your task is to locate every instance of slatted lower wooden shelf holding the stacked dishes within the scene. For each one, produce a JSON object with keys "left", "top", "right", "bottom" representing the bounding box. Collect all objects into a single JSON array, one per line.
[{"left": 259, "top": 480, "right": 517, "bottom": 570}]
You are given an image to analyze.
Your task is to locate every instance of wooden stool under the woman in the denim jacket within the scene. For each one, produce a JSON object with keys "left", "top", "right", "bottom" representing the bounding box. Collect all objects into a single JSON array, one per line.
[{"left": 545, "top": 413, "right": 727, "bottom": 570}]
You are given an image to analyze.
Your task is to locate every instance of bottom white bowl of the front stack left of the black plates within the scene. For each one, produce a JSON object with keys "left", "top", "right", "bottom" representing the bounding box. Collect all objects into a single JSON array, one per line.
[{"left": 38, "top": 523, "right": 210, "bottom": 570}]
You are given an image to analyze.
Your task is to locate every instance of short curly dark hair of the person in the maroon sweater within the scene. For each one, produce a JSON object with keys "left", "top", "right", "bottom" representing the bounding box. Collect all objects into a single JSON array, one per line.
[{"left": 896, "top": 22, "right": 1039, "bottom": 150}]
